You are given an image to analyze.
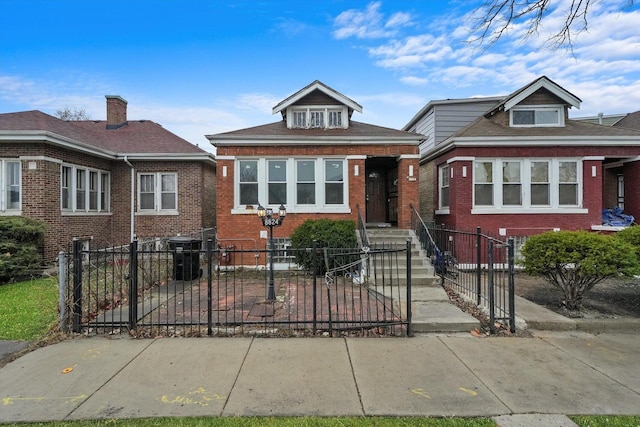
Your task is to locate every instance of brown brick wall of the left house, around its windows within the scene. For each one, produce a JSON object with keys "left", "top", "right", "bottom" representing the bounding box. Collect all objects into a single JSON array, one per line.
[{"left": 2, "top": 144, "right": 215, "bottom": 262}]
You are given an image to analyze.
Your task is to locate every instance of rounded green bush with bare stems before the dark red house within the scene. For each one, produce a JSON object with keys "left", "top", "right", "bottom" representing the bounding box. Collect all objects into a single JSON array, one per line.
[{"left": 519, "top": 231, "right": 640, "bottom": 310}]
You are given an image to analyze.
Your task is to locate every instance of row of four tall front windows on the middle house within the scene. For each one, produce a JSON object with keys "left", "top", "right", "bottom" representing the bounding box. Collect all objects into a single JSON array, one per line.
[{"left": 235, "top": 157, "right": 349, "bottom": 212}]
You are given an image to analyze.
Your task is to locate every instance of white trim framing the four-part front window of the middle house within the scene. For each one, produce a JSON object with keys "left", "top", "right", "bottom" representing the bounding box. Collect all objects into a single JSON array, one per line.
[{"left": 231, "top": 156, "right": 351, "bottom": 214}]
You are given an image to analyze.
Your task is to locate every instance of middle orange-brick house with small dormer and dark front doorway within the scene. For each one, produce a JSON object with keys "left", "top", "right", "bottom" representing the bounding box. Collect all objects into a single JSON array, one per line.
[{"left": 207, "top": 80, "right": 423, "bottom": 262}]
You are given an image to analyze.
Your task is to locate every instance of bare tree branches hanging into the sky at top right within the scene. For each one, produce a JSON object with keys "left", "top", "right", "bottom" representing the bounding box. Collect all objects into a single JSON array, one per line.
[{"left": 472, "top": 0, "right": 634, "bottom": 50}]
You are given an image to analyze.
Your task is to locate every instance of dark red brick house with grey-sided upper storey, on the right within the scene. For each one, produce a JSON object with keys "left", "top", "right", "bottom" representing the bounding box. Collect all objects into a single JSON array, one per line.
[{"left": 403, "top": 76, "right": 640, "bottom": 241}]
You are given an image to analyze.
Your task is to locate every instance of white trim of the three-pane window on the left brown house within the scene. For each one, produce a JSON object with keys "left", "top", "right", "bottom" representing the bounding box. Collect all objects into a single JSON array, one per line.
[{"left": 60, "top": 163, "right": 111, "bottom": 216}]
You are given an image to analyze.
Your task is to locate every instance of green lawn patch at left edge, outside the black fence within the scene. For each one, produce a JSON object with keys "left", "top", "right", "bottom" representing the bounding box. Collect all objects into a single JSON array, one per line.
[{"left": 0, "top": 277, "right": 58, "bottom": 341}]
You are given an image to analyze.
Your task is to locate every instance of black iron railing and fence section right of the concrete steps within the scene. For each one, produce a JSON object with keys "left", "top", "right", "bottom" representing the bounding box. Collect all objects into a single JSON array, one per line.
[{"left": 412, "top": 207, "right": 515, "bottom": 333}]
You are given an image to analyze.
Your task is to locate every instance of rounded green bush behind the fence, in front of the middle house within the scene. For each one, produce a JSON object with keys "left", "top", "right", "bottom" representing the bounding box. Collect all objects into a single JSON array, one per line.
[{"left": 291, "top": 219, "right": 358, "bottom": 274}]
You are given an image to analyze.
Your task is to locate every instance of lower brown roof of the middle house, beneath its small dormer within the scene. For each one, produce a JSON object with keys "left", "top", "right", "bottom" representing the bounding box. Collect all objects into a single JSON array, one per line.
[{"left": 206, "top": 121, "right": 424, "bottom": 146}]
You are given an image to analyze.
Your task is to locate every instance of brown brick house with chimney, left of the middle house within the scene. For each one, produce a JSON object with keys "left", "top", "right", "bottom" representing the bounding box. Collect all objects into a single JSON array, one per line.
[{"left": 0, "top": 96, "right": 216, "bottom": 262}]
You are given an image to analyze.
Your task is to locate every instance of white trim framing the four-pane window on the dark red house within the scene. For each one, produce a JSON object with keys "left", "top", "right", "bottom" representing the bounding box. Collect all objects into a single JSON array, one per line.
[{"left": 471, "top": 158, "right": 588, "bottom": 214}]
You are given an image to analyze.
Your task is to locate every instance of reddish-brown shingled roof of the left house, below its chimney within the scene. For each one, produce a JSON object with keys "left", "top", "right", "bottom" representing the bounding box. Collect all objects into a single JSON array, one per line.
[{"left": 0, "top": 110, "right": 212, "bottom": 160}]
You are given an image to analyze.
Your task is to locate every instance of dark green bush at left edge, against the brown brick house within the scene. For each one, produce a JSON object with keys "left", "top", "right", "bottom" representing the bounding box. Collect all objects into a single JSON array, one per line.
[{"left": 0, "top": 217, "right": 45, "bottom": 283}]
